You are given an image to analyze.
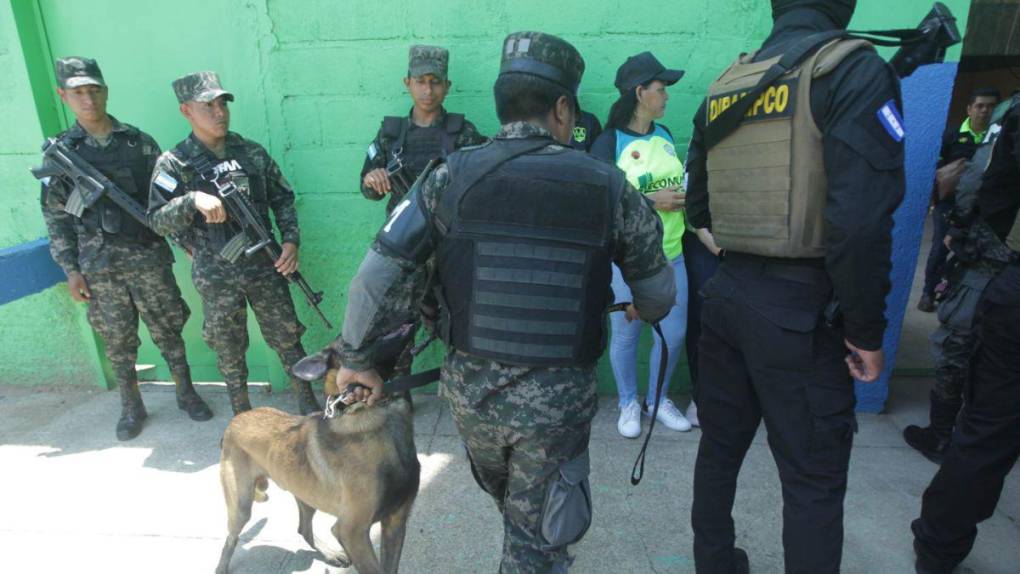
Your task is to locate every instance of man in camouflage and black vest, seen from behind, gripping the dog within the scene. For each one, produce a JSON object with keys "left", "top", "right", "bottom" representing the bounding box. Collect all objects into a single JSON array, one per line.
[{"left": 338, "top": 32, "right": 676, "bottom": 573}]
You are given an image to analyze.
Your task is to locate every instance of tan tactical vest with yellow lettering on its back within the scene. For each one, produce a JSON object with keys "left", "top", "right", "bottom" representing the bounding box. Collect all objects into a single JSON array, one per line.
[{"left": 706, "top": 40, "right": 874, "bottom": 258}]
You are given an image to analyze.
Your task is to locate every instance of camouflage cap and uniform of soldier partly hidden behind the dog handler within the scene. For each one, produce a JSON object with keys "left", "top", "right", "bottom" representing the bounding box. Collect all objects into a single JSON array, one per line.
[{"left": 360, "top": 46, "right": 487, "bottom": 215}]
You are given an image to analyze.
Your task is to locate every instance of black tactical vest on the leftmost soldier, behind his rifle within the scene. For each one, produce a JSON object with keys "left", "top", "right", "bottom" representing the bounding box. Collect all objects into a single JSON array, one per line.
[{"left": 61, "top": 128, "right": 162, "bottom": 243}]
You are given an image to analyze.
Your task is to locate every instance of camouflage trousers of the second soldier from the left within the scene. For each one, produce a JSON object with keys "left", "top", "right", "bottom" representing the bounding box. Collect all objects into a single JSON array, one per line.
[{"left": 192, "top": 265, "right": 305, "bottom": 401}]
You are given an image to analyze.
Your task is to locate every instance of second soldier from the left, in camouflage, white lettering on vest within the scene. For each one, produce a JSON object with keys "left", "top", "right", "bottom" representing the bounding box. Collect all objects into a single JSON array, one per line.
[{"left": 149, "top": 71, "right": 319, "bottom": 414}]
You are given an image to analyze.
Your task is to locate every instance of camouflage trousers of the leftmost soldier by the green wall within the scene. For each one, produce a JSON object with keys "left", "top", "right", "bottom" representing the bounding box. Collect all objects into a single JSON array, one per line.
[{"left": 85, "top": 265, "right": 191, "bottom": 383}]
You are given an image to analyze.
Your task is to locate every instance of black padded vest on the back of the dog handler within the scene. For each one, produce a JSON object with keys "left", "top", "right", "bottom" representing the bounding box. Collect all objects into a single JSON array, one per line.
[{"left": 435, "top": 138, "right": 623, "bottom": 366}]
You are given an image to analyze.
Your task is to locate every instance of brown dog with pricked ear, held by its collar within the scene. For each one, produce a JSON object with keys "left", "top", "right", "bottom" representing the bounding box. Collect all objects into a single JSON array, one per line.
[{"left": 216, "top": 328, "right": 421, "bottom": 574}]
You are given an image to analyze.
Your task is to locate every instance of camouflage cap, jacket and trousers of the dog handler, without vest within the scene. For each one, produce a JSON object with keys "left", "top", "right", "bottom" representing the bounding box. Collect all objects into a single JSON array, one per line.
[{"left": 342, "top": 33, "right": 675, "bottom": 573}]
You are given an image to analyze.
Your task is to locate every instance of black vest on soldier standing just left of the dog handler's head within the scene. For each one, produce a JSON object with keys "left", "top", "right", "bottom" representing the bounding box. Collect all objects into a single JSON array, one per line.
[{"left": 383, "top": 113, "right": 464, "bottom": 177}]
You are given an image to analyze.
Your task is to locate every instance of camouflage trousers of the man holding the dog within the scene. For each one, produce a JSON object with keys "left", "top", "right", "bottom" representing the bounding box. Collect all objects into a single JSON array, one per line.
[{"left": 441, "top": 353, "right": 598, "bottom": 574}]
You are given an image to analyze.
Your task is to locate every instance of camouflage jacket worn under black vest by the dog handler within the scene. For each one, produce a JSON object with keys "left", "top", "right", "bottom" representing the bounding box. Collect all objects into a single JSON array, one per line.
[{"left": 341, "top": 122, "right": 675, "bottom": 414}]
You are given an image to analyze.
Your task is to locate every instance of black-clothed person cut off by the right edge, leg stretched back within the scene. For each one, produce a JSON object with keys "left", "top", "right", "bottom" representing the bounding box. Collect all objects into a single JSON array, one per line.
[{"left": 913, "top": 89, "right": 1020, "bottom": 574}]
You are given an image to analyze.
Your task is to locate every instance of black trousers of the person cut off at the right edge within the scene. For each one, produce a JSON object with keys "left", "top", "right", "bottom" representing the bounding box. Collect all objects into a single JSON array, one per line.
[{"left": 912, "top": 264, "right": 1020, "bottom": 573}]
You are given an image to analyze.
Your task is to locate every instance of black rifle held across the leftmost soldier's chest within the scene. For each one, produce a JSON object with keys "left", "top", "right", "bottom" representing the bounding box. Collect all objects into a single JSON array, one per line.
[{"left": 32, "top": 138, "right": 149, "bottom": 227}]
